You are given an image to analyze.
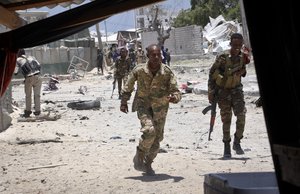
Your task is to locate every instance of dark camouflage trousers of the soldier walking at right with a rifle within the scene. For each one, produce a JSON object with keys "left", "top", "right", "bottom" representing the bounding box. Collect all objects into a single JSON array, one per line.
[{"left": 218, "top": 87, "right": 247, "bottom": 142}]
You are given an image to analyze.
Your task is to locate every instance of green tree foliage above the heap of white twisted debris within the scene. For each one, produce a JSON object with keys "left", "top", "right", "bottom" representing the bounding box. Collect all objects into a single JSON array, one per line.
[{"left": 172, "top": 0, "right": 241, "bottom": 27}]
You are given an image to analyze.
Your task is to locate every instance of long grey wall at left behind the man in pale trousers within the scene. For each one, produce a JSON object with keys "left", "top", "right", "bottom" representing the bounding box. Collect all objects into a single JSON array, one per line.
[{"left": 25, "top": 47, "right": 97, "bottom": 74}]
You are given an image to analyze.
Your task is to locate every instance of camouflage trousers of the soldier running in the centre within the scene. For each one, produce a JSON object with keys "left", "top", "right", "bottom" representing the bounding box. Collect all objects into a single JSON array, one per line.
[{"left": 137, "top": 106, "right": 168, "bottom": 161}]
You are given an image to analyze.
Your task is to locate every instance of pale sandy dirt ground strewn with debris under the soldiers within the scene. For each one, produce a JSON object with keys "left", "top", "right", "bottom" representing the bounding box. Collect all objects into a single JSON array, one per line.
[{"left": 0, "top": 57, "right": 274, "bottom": 194}]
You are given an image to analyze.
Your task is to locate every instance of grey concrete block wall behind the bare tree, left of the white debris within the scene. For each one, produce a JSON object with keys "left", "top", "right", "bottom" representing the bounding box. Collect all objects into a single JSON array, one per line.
[{"left": 141, "top": 25, "right": 204, "bottom": 55}]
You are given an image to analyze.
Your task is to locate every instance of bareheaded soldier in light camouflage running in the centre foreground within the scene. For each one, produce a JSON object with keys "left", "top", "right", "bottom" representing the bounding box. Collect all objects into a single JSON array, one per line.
[{"left": 120, "top": 44, "right": 181, "bottom": 175}]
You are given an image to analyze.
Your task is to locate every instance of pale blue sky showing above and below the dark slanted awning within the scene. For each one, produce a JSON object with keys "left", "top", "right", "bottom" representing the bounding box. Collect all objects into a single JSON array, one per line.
[{"left": 32, "top": 0, "right": 190, "bottom": 34}]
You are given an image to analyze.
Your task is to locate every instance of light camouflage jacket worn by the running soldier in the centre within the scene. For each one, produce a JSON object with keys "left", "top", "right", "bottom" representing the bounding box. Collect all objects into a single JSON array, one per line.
[{"left": 121, "top": 64, "right": 181, "bottom": 109}]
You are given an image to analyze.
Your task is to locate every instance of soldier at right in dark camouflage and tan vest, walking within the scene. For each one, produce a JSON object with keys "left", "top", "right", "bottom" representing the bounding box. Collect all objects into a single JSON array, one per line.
[{"left": 208, "top": 33, "right": 250, "bottom": 158}]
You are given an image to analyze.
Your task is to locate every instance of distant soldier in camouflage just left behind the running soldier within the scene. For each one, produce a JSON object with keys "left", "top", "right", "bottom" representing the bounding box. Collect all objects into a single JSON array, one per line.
[{"left": 114, "top": 48, "right": 131, "bottom": 99}]
